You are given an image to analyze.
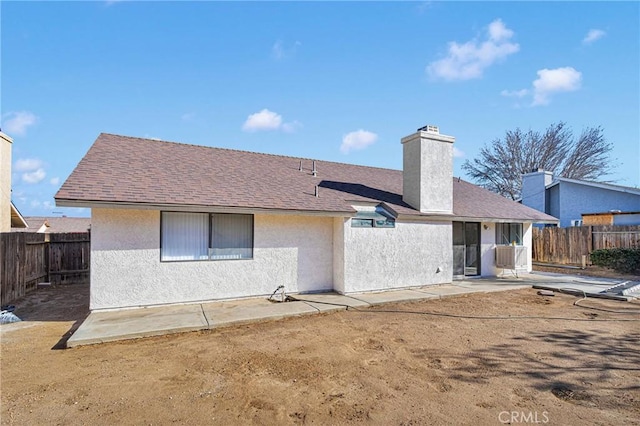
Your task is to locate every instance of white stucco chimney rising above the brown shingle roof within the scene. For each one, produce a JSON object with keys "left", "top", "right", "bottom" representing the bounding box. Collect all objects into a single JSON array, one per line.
[{"left": 401, "top": 126, "right": 455, "bottom": 214}]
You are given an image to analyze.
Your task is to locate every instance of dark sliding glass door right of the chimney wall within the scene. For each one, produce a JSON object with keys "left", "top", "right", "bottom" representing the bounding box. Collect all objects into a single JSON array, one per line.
[{"left": 453, "top": 222, "right": 480, "bottom": 277}]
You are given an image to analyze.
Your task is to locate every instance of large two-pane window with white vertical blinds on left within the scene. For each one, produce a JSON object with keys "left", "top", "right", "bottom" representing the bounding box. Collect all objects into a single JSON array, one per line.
[{"left": 160, "top": 212, "right": 253, "bottom": 261}]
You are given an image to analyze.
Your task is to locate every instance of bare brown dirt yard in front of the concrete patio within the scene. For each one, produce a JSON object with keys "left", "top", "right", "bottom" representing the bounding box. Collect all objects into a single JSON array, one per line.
[{"left": 0, "top": 286, "right": 640, "bottom": 425}]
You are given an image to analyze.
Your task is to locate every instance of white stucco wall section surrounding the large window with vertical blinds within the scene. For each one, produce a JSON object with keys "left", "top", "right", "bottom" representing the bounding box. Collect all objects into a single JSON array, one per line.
[{"left": 90, "top": 208, "right": 333, "bottom": 310}]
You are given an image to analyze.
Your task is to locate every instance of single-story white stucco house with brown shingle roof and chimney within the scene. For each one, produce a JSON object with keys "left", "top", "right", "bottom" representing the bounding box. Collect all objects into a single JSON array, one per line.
[{"left": 55, "top": 126, "right": 556, "bottom": 310}]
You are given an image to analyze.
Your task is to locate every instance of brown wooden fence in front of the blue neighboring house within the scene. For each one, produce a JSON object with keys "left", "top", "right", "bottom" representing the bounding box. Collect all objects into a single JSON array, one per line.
[{"left": 532, "top": 225, "right": 640, "bottom": 265}]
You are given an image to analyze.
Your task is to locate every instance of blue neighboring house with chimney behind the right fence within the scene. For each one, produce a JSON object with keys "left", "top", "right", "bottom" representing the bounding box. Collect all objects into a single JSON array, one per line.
[{"left": 521, "top": 169, "right": 640, "bottom": 227}]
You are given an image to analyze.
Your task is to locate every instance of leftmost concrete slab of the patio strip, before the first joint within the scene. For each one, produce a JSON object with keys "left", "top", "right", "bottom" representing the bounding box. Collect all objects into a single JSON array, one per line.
[{"left": 67, "top": 305, "right": 209, "bottom": 347}]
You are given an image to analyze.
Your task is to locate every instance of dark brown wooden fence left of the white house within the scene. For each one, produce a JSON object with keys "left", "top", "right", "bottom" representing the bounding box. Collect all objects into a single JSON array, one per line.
[{"left": 0, "top": 232, "right": 91, "bottom": 305}]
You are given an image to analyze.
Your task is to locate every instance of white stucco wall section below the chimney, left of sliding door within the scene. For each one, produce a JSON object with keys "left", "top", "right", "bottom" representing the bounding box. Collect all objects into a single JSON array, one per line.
[{"left": 335, "top": 220, "right": 453, "bottom": 293}]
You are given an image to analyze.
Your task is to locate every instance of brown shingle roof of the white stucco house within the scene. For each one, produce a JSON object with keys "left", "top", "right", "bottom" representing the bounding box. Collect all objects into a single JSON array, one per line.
[{"left": 55, "top": 133, "right": 557, "bottom": 222}]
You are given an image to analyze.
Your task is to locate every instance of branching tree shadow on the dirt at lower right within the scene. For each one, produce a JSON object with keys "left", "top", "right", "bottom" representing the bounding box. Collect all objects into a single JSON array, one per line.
[{"left": 442, "top": 329, "right": 640, "bottom": 399}]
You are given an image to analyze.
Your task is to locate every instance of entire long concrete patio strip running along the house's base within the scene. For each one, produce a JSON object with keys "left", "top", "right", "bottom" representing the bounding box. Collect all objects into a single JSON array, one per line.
[{"left": 67, "top": 274, "right": 612, "bottom": 347}]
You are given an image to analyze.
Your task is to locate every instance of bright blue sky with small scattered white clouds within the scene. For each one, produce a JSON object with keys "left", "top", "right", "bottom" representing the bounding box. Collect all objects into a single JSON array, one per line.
[{"left": 0, "top": 1, "right": 640, "bottom": 216}]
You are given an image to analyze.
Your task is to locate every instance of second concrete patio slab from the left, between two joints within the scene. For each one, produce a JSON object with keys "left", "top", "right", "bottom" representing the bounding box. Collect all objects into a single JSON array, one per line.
[{"left": 202, "top": 299, "right": 318, "bottom": 328}]
